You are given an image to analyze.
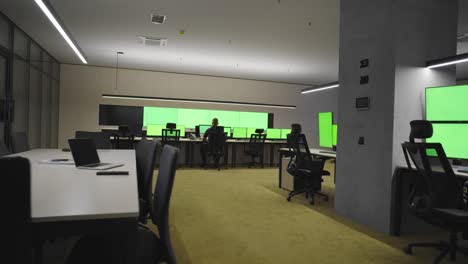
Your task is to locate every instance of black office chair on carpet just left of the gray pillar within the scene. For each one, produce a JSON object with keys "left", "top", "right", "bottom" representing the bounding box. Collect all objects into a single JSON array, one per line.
[{"left": 287, "top": 134, "right": 328, "bottom": 204}]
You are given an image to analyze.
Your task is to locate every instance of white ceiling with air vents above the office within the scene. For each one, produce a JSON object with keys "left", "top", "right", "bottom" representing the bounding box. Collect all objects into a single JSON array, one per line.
[{"left": 0, "top": 0, "right": 339, "bottom": 85}]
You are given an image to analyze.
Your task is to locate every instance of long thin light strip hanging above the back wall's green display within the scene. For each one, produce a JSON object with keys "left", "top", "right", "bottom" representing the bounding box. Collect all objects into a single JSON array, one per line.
[{"left": 102, "top": 94, "right": 296, "bottom": 109}]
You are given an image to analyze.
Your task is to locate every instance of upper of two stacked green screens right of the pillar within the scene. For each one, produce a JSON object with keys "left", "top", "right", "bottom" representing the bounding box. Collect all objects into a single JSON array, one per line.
[{"left": 426, "top": 85, "right": 468, "bottom": 121}]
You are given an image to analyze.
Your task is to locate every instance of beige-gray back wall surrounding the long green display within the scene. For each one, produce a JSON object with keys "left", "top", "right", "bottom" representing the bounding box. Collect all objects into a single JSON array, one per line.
[{"left": 59, "top": 64, "right": 336, "bottom": 147}]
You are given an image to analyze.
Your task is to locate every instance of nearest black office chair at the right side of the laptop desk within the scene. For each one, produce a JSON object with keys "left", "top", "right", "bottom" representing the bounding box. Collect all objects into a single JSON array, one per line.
[{"left": 67, "top": 145, "right": 179, "bottom": 264}]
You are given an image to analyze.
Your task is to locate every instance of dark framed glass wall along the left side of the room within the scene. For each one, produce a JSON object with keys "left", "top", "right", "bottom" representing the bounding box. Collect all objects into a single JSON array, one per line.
[{"left": 0, "top": 12, "right": 60, "bottom": 148}]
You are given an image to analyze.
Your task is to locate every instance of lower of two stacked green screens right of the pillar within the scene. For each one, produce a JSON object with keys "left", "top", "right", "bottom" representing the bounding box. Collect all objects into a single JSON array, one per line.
[{"left": 426, "top": 123, "right": 468, "bottom": 159}]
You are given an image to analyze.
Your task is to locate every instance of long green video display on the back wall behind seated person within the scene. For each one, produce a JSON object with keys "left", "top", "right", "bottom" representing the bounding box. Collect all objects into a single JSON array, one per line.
[{"left": 143, "top": 107, "right": 268, "bottom": 129}]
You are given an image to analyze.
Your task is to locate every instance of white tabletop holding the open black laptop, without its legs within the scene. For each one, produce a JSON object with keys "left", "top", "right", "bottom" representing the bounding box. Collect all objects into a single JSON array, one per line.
[{"left": 11, "top": 149, "right": 138, "bottom": 222}]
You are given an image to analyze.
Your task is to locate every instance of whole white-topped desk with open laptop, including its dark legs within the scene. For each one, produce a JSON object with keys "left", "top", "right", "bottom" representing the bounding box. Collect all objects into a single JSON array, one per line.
[{"left": 12, "top": 149, "right": 139, "bottom": 263}]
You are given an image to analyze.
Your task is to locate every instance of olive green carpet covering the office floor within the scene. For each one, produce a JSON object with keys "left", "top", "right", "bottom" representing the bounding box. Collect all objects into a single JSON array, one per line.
[{"left": 152, "top": 164, "right": 468, "bottom": 264}]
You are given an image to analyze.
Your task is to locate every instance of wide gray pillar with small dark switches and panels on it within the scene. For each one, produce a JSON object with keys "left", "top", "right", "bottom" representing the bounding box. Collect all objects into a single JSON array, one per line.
[{"left": 335, "top": 0, "right": 457, "bottom": 233}]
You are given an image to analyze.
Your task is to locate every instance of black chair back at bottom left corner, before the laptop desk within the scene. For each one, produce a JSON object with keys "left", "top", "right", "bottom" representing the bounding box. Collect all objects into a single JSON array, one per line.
[{"left": 0, "top": 157, "right": 33, "bottom": 263}]
